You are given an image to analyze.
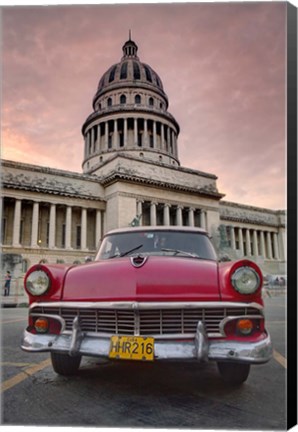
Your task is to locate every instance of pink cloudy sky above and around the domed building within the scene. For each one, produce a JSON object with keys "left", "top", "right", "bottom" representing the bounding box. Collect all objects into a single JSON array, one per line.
[{"left": 2, "top": 2, "right": 286, "bottom": 209}]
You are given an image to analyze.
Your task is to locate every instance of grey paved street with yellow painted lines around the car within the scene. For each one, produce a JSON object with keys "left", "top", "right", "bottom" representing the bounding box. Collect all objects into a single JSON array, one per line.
[{"left": 1, "top": 295, "right": 287, "bottom": 430}]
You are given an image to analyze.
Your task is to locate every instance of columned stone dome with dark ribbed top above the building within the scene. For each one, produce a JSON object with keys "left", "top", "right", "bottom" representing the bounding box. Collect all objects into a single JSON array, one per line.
[{"left": 82, "top": 38, "right": 180, "bottom": 174}]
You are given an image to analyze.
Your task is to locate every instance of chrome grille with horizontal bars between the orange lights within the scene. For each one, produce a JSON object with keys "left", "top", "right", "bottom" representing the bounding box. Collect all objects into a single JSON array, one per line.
[{"left": 30, "top": 306, "right": 262, "bottom": 336}]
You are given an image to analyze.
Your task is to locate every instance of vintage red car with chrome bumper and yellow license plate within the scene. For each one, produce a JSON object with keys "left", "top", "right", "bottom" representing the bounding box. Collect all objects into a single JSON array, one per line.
[{"left": 21, "top": 226, "right": 272, "bottom": 385}]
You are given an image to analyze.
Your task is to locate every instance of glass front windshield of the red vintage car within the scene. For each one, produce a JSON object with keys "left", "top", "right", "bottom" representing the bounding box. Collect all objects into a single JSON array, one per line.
[{"left": 96, "top": 229, "right": 217, "bottom": 260}]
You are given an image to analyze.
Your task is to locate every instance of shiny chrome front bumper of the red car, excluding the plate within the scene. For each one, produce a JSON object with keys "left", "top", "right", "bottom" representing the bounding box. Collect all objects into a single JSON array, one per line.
[{"left": 21, "top": 320, "right": 272, "bottom": 364}]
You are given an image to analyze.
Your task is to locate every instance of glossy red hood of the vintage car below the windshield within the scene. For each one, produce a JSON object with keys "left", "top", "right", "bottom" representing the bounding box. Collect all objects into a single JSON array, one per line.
[{"left": 62, "top": 256, "right": 220, "bottom": 301}]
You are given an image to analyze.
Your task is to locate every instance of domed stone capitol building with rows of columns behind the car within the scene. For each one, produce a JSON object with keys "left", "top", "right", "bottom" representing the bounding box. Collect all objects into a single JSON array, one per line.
[{"left": 1, "top": 37, "right": 286, "bottom": 286}]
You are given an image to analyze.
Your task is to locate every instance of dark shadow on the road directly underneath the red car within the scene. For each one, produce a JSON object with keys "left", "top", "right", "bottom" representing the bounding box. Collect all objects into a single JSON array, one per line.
[{"left": 79, "top": 359, "right": 247, "bottom": 396}]
